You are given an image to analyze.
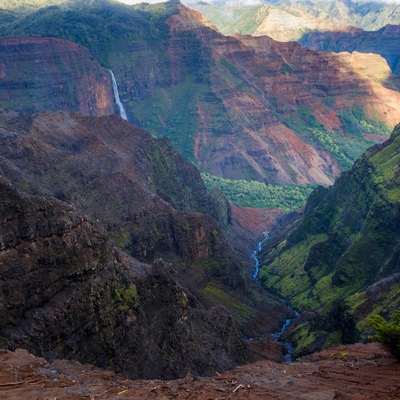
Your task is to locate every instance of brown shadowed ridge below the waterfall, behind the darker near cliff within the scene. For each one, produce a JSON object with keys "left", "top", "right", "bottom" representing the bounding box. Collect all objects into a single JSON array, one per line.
[{"left": 0, "top": 112, "right": 285, "bottom": 330}]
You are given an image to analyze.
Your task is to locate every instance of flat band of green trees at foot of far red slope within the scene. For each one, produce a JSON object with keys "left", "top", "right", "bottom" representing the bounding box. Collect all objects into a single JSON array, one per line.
[{"left": 201, "top": 173, "right": 314, "bottom": 211}]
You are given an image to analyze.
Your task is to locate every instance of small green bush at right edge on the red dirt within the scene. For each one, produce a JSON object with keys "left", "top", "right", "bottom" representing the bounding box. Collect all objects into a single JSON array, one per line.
[{"left": 368, "top": 310, "right": 400, "bottom": 361}]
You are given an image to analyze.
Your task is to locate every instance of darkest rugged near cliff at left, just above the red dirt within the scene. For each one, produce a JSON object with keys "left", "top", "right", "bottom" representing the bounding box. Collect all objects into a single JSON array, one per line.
[{"left": 0, "top": 178, "right": 246, "bottom": 378}]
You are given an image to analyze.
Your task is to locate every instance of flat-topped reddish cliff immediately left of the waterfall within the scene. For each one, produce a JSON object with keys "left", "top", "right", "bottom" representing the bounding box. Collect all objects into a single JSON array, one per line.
[{"left": 0, "top": 37, "right": 114, "bottom": 116}]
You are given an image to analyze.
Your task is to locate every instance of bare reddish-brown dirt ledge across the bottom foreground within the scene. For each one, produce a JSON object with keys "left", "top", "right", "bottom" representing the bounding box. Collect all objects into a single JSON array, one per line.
[{"left": 0, "top": 343, "right": 400, "bottom": 400}]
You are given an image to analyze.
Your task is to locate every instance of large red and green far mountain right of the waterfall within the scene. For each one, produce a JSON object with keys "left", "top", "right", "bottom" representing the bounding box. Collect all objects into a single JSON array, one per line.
[{"left": 0, "top": 1, "right": 400, "bottom": 185}]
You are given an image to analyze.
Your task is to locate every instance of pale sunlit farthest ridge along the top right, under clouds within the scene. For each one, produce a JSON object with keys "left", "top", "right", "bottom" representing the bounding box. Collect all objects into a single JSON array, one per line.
[{"left": 190, "top": 0, "right": 400, "bottom": 41}]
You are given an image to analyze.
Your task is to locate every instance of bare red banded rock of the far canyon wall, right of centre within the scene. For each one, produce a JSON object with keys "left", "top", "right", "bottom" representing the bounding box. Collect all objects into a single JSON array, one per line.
[{"left": 162, "top": 7, "right": 400, "bottom": 185}]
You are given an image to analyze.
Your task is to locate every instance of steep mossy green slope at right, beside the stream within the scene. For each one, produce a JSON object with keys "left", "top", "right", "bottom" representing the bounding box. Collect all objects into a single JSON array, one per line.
[{"left": 259, "top": 125, "right": 400, "bottom": 353}]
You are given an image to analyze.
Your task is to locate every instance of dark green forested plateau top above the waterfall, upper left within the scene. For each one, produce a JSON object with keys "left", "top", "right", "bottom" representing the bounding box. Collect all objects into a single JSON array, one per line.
[{"left": 0, "top": 0, "right": 177, "bottom": 68}]
